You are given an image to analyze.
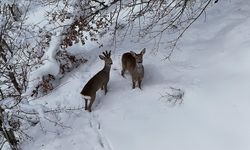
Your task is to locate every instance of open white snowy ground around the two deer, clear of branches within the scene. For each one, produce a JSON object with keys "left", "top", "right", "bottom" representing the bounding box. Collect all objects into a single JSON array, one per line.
[{"left": 23, "top": 0, "right": 250, "bottom": 150}]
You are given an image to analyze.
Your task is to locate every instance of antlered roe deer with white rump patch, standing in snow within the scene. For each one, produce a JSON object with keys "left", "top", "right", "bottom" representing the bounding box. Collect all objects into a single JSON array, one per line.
[{"left": 81, "top": 51, "right": 113, "bottom": 112}]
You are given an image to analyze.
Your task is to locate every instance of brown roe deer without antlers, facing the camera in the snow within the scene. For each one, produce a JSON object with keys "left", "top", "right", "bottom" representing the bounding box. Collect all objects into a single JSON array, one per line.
[{"left": 121, "top": 48, "right": 146, "bottom": 89}]
